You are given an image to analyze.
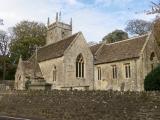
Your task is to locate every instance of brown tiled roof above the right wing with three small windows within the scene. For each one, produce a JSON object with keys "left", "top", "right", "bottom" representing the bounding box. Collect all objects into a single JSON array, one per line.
[{"left": 91, "top": 35, "right": 148, "bottom": 64}]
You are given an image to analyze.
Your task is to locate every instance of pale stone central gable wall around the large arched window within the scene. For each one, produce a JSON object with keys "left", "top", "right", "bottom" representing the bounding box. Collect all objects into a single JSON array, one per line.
[{"left": 64, "top": 33, "right": 94, "bottom": 89}]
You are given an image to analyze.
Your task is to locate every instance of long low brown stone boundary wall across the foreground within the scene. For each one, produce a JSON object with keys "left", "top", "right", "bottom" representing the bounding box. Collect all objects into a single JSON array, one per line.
[{"left": 0, "top": 91, "right": 160, "bottom": 120}]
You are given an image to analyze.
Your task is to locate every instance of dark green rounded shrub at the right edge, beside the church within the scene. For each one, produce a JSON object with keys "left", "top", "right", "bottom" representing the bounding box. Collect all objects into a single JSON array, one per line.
[{"left": 144, "top": 65, "right": 160, "bottom": 91}]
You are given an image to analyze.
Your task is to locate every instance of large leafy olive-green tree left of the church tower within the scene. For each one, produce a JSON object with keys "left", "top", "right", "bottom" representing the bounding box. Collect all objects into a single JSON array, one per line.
[{"left": 10, "top": 21, "right": 46, "bottom": 63}]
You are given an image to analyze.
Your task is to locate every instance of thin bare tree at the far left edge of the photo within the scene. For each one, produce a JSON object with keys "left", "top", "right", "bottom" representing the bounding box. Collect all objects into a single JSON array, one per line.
[{"left": 0, "top": 31, "right": 9, "bottom": 80}]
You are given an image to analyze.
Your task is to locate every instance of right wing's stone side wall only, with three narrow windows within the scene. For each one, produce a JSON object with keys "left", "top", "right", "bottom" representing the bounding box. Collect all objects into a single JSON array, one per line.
[{"left": 94, "top": 59, "right": 138, "bottom": 91}]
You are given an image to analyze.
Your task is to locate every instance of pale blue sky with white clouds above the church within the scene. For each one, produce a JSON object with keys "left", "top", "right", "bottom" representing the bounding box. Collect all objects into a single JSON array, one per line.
[{"left": 0, "top": 0, "right": 157, "bottom": 42}]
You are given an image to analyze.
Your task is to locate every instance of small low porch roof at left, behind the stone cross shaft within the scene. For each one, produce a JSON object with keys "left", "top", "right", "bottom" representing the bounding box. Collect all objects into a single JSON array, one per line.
[{"left": 22, "top": 61, "right": 43, "bottom": 78}]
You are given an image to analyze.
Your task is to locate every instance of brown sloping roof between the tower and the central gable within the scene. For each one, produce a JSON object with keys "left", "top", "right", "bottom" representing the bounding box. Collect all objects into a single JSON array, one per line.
[{"left": 37, "top": 33, "right": 79, "bottom": 62}]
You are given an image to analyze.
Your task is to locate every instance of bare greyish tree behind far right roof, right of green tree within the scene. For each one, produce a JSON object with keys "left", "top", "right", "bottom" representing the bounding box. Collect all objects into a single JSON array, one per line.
[{"left": 125, "top": 19, "right": 151, "bottom": 35}]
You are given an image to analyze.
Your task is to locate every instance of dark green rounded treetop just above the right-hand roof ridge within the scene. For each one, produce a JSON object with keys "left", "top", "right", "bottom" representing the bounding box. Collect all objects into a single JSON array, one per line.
[{"left": 102, "top": 30, "right": 128, "bottom": 43}]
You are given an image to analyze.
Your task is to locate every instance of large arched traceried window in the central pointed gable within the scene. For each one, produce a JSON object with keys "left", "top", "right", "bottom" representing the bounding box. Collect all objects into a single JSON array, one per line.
[{"left": 76, "top": 54, "right": 84, "bottom": 78}]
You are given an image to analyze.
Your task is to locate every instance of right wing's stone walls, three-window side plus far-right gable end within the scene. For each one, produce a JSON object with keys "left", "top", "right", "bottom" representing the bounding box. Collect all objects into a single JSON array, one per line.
[{"left": 94, "top": 35, "right": 160, "bottom": 91}]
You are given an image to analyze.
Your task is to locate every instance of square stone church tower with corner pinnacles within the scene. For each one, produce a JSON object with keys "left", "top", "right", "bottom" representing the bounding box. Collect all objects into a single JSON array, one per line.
[{"left": 46, "top": 13, "right": 72, "bottom": 45}]
